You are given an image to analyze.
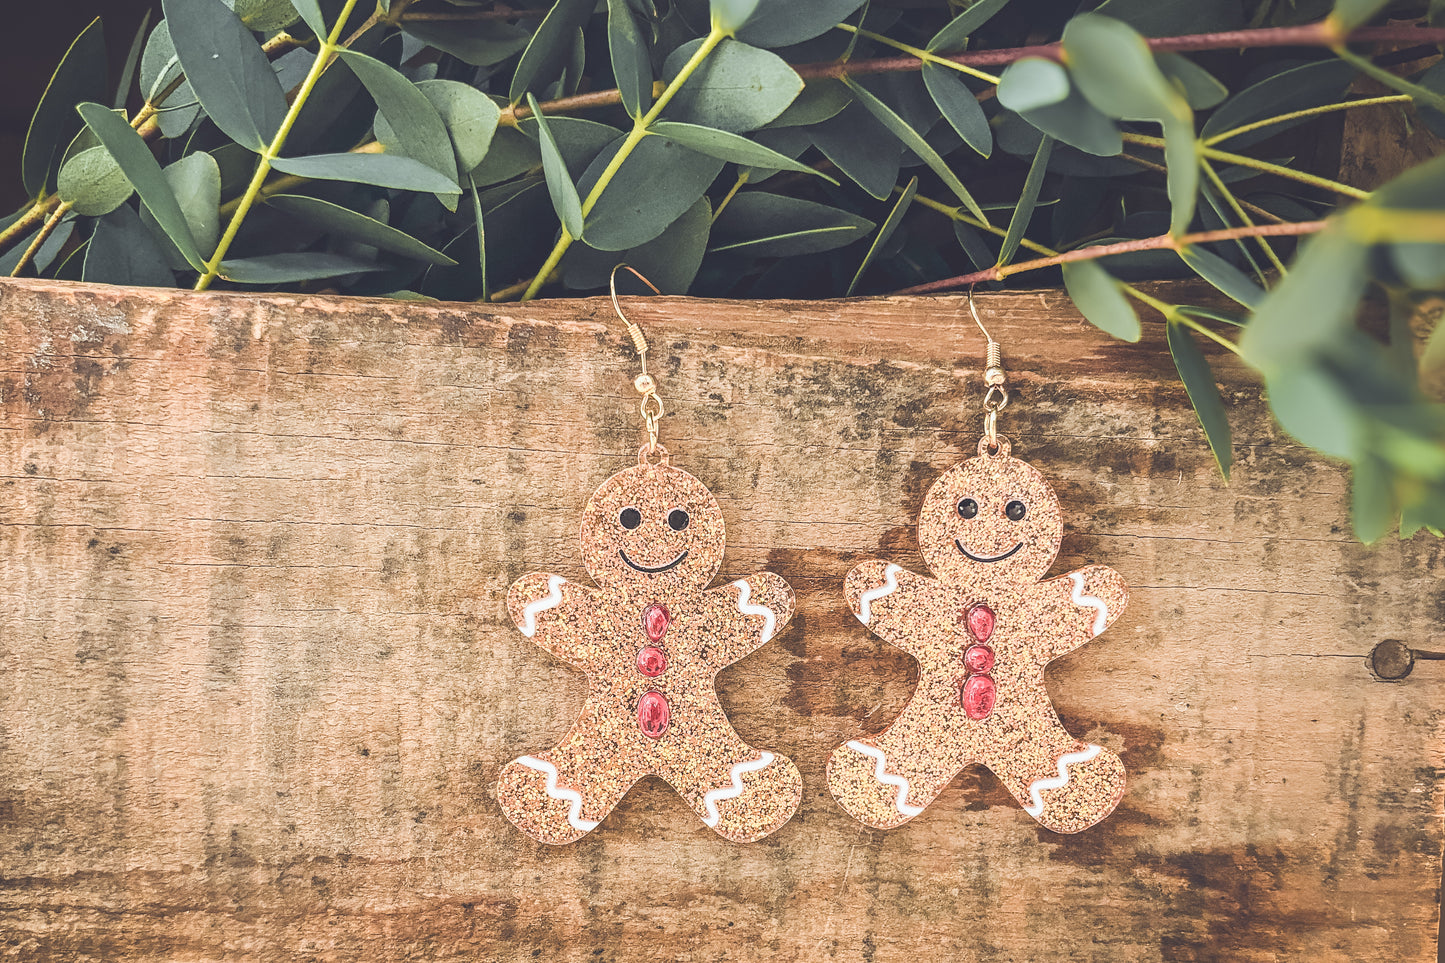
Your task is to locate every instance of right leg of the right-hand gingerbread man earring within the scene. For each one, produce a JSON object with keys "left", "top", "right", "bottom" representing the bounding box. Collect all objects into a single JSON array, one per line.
[{"left": 983, "top": 724, "right": 1124, "bottom": 833}]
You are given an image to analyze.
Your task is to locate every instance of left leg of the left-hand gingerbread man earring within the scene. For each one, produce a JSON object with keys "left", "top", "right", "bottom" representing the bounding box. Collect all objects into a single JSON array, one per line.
[{"left": 497, "top": 713, "right": 643, "bottom": 844}]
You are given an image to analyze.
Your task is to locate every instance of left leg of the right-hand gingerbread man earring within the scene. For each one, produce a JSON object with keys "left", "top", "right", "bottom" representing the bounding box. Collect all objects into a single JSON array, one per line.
[{"left": 828, "top": 700, "right": 970, "bottom": 829}]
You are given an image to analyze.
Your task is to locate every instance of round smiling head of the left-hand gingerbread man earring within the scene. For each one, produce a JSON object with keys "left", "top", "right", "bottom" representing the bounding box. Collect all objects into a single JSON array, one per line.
[{"left": 582, "top": 463, "right": 725, "bottom": 597}]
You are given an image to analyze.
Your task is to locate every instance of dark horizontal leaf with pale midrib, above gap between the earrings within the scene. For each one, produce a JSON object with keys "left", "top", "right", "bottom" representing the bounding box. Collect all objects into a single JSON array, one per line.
[{"left": 711, "top": 191, "right": 873, "bottom": 257}]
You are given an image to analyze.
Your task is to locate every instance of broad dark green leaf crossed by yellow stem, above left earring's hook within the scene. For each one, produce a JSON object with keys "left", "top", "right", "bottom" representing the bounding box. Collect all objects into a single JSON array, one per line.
[{"left": 578, "top": 137, "right": 723, "bottom": 250}]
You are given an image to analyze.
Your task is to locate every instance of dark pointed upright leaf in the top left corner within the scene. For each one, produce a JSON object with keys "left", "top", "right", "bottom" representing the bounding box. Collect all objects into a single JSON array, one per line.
[{"left": 24, "top": 17, "right": 105, "bottom": 198}]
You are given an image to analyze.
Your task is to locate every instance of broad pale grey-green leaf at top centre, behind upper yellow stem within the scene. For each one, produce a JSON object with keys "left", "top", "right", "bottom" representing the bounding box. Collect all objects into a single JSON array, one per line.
[{"left": 663, "top": 40, "right": 803, "bottom": 133}]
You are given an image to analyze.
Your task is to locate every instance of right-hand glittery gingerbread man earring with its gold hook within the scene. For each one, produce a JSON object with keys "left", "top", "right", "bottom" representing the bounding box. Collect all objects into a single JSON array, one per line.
[{"left": 828, "top": 291, "right": 1129, "bottom": 833}]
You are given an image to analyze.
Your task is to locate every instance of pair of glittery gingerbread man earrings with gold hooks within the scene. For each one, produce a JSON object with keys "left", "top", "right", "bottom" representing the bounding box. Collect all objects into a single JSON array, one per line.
[{"left": 497, "top": 265, "right": 1127, "bottom": 843}]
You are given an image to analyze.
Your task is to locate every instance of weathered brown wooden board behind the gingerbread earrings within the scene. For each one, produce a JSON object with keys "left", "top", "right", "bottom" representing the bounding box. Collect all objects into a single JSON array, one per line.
[{"left": 0, "top": 282, "right": 1445, "bottom": 960}]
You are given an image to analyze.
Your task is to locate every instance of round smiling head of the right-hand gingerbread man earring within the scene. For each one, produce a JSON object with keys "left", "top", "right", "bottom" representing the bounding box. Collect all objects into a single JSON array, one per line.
[{"left": 918, "top": 448, "right": 1064, "bottom": 584}]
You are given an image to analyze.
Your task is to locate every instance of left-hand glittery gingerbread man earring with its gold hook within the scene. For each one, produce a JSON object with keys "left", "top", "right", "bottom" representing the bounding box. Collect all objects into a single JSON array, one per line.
[{"left": 497, "top": 265, "right": 802, "bottom": 843}]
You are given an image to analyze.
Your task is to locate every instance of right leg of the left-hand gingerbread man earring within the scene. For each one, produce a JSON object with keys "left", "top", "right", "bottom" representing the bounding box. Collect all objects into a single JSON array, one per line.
[{"left": 659, "top": 710, "right": 803, "bottom": 843}]
